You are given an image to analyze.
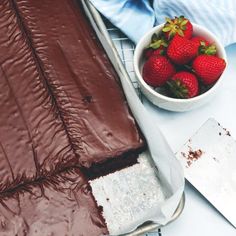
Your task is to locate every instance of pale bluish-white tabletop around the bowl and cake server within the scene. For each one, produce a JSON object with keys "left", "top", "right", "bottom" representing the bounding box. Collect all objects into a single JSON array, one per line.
[{"left": 144, "top": 44, "right": 236, "bottom": 236}]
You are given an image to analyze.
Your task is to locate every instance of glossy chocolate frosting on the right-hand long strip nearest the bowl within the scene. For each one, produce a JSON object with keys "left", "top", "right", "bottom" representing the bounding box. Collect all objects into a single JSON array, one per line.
[{"left": 14, "top": 0, "right": 143, "bottom": 167}]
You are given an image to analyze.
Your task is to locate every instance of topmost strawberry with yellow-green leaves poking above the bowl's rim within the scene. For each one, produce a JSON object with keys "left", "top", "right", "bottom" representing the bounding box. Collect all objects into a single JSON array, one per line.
[{"left": 162, "top": 16, "right": 193, "bottom": 40}]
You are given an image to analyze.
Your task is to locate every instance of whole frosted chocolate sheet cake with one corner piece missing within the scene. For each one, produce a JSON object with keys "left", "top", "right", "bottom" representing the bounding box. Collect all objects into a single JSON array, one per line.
[{"left": 0, "top": 0, "right": 145, "bottom": 236}]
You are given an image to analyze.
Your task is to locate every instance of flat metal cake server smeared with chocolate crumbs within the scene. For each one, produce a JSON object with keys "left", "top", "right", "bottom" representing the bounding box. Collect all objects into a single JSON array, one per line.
[{"left": 177, "top": 119, "right": 236, "bottom": 227}]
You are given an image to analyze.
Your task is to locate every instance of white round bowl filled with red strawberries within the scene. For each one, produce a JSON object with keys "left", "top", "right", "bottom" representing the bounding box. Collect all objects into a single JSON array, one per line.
[{"left": 134, "top": 16, "right": 227, "bottom": 111}]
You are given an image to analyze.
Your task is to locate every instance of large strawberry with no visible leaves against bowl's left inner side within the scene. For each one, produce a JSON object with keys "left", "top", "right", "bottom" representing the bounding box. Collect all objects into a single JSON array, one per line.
[{"left": 143, "top": 56, "right": 175, "bottom": 87}]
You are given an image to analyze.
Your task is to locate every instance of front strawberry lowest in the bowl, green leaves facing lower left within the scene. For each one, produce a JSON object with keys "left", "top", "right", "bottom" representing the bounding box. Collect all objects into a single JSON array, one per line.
[{"left": 167, "top": 71, "right": 199, "bottom": 98}]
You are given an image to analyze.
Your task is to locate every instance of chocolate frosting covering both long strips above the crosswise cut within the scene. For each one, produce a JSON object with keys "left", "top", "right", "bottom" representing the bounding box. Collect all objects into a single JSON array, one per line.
[{"left": 0, "top": 0, "right": 144, "bottom": 192}]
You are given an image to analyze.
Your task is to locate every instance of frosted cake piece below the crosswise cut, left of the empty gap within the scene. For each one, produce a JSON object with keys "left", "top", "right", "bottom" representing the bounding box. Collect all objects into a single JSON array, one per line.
[{"left": 0, "top": 169, "right": 108, "bottom": 236}]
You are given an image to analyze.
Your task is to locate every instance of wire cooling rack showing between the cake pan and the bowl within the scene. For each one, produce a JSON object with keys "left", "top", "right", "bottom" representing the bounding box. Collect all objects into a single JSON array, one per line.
[{"left": 103, "top": 19, "right": 143, "bottom": 101}]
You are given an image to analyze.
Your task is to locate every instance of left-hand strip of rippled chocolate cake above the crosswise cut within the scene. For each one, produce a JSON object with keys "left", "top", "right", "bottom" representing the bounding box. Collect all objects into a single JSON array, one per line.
[{"left": 0, "top": 0, "right": 76, "bottom": 192}]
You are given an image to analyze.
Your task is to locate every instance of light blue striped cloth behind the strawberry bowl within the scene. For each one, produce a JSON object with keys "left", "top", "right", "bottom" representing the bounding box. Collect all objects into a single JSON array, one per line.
[{"left": 90, "top": 0, "right": 236, "bottom": 46}]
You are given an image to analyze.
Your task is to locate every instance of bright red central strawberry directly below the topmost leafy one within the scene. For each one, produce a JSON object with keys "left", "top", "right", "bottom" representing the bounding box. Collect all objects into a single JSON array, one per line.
[{"left": 167, "top": 35, "right": 198, "bottom": 65}]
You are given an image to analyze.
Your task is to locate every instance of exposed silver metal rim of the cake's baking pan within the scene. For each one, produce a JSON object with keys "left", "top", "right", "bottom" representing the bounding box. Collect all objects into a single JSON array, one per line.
[{"left": 81, "top": 0, "right": 185, "bottom": 236}]
